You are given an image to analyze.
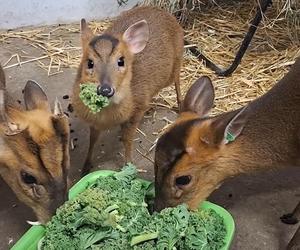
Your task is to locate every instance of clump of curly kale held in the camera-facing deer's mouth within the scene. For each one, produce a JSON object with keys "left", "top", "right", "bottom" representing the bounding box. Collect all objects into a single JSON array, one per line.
[{"left": 79, "top": 83, "right": 109, "bottom": 114}]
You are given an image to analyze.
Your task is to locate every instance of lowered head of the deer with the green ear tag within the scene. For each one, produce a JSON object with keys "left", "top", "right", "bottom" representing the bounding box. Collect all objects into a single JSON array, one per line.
[{"left": 155, "top": 77, "right": 249, "bottom": 210}]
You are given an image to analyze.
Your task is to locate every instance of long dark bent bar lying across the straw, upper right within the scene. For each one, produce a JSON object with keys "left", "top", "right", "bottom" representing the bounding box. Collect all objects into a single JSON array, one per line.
[{"left": 185, "top": 0, "right": 272, "bottom": 76}]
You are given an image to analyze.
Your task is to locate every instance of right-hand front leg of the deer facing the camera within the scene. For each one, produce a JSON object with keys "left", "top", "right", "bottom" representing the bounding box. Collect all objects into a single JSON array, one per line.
[{"left": 121, "top": 109, "right": 145, "bottom": 163}]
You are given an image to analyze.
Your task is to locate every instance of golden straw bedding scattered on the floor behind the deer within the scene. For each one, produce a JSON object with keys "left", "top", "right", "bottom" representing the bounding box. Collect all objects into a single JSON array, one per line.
[{"left": 0, "top": 0, "right": 300, "bottom": 117}]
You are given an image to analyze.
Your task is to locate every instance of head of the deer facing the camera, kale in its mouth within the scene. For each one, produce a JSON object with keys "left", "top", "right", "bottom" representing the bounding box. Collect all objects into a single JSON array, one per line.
[{"left": 78, "top": 19, "right": 149, "bottom": 104}]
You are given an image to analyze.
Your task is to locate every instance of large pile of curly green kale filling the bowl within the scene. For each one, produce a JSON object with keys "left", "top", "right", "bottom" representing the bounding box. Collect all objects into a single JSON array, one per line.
[{"left": 40, "top": 165, "right": 226, "bottom": 250}]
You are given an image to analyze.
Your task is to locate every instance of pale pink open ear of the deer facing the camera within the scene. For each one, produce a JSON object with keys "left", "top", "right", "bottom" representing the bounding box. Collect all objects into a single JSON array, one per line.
[{"left": 123, "top": 20, "right": 149, "bottom": 54}]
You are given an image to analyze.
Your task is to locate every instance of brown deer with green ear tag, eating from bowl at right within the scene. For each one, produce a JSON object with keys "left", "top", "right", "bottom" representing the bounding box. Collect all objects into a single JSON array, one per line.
[{"left": 155, "top": 58, "right": 300, "bottom": 248}]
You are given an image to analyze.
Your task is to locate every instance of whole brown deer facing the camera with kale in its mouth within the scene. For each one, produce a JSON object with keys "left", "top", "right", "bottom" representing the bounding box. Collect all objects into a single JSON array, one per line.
[{"left": 72, "top": 7, "right": 183, "bottom": 174}]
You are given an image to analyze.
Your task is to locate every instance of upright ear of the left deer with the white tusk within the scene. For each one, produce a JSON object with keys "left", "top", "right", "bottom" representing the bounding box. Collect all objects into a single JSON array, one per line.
[{"left": 24, "top": 80, "right": 50, "bottom": 111}]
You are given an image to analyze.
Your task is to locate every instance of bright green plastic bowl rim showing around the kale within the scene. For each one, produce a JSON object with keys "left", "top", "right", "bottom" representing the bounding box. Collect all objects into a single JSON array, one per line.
[{"left": 11, "top": 170, "right": 235, "bottom": 250}]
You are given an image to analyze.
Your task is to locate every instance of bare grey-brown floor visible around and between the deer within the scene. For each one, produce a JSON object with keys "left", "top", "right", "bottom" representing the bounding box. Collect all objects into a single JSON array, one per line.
[{"left": 0, "top": 7, "right": 300, "bottom": 250}]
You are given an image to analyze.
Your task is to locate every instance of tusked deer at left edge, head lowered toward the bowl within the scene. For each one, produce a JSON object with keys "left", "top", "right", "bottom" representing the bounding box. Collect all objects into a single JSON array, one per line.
[{"left": 0, "top": 66, "right": 70, "bottom": 223}]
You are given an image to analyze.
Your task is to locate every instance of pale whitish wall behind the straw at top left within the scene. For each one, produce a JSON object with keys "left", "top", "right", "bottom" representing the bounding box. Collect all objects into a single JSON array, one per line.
[{"left": 0, "top": 0, "right": 138, "bottom": 29}]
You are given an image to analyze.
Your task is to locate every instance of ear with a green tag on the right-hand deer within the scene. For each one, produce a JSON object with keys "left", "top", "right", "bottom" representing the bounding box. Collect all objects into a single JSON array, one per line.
[{"left": 201, "top": 106, "right": 250, "bottom": 145}]
